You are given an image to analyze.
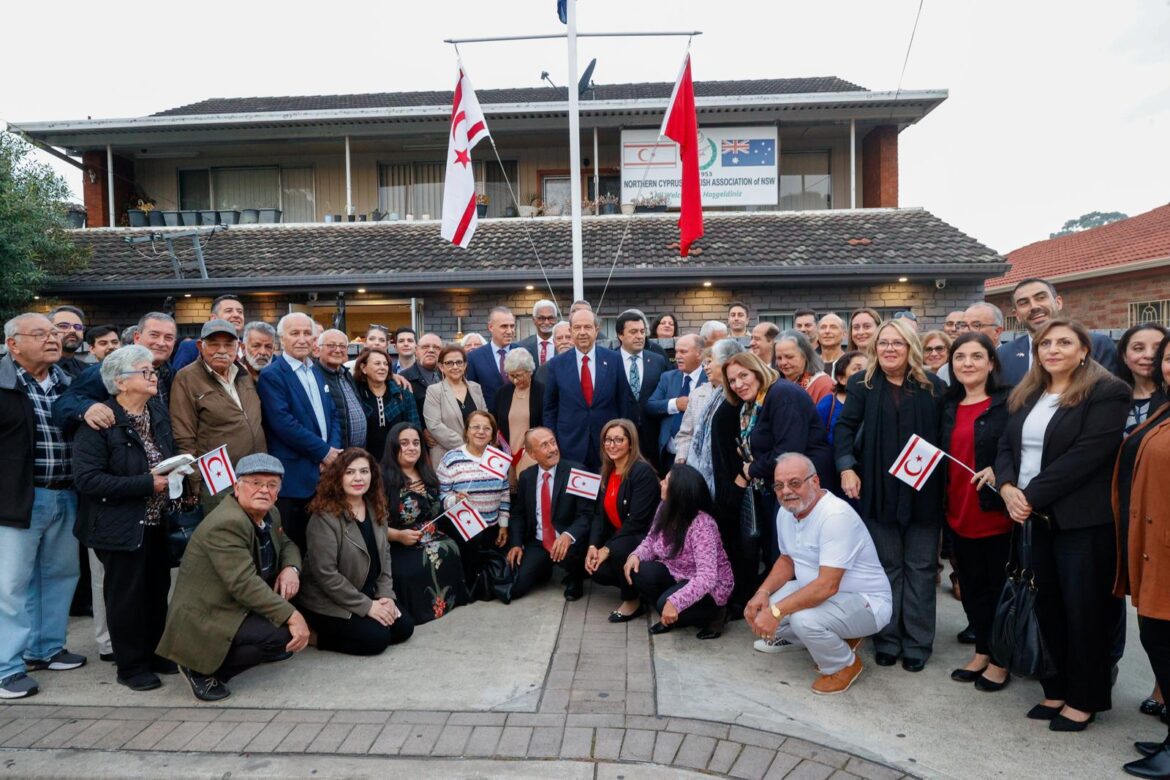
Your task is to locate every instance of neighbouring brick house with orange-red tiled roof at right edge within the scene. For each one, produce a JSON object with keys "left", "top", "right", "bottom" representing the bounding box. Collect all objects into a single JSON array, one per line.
[{"left": 985, "top": 205, "right": 1170, "bottom": 330}]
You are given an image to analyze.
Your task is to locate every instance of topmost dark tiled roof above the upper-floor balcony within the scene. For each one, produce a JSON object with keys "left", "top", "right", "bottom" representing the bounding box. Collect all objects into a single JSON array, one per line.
[{"left": 152, "top": 76, "right": 867, "bottom": 117}]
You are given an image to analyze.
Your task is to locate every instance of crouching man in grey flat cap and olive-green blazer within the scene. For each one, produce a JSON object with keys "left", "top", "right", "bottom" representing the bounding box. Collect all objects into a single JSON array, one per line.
[{"left": 158, "top": 454, "right": 309, "bottom": 702}]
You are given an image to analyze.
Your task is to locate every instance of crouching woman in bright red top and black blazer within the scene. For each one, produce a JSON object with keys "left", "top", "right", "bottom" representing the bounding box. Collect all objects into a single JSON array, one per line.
[{"left": 585, "top": 417, "right": 661, "bottom": 623}]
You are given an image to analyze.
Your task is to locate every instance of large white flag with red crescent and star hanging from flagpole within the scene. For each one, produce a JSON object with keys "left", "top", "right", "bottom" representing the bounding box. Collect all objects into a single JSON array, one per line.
[{"left": 441, "top": 62, "right": 490, "bottom": 249}]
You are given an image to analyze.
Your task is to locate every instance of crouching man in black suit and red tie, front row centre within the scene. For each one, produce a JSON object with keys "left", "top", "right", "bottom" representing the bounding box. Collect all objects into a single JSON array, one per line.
[{"left": 508, "top": 428, "right": 594, "bottom": 601}]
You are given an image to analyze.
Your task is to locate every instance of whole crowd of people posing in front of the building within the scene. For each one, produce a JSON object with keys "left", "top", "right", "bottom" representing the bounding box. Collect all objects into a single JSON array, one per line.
[{"left": 0, "top": 279, "right": 1170, "bottom": 776}]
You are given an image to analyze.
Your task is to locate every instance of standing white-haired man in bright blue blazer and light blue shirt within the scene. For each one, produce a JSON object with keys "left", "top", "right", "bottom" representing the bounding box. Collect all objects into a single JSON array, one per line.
[{"left": 256, "top": 313, "right": 342, "bottom": 553}]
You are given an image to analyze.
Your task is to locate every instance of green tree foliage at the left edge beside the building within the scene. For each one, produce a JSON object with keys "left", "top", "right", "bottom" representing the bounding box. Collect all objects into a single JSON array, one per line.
[{"left": 0, "top": 131, "right": 90, "bottom": 319}]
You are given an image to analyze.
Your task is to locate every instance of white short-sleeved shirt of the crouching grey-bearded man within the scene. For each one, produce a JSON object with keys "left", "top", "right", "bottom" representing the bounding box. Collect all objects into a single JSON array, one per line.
[{"left": 776, "top": 491, "right": 894, "bottom": 626}]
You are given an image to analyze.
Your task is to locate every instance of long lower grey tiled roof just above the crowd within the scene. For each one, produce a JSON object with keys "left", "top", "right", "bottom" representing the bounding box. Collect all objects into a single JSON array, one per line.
[{"left": 50, "top": 209, "right": 1004, "bottom": 291}]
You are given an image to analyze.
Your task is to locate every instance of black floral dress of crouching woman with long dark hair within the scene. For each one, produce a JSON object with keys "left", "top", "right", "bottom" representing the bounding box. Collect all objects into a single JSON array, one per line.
[{"left": 390, "top": 482, "right": 468, "bottom": 624}]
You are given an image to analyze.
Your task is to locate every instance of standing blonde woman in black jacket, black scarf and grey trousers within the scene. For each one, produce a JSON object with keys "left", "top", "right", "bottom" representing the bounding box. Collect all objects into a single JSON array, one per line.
[{"left": 833, "top": 319, "right": 947, "bottom": 671}]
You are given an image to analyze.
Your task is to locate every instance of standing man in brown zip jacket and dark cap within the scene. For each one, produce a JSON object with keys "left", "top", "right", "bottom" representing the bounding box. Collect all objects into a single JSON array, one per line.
[{"left": 171, "top": 319, "right": 268, "bottom": 513}]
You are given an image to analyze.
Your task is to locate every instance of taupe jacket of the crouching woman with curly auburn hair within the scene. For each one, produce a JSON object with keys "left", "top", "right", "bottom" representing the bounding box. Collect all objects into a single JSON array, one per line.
[{"left": 297, "top": 503, "right": 397, "bottom": 617}]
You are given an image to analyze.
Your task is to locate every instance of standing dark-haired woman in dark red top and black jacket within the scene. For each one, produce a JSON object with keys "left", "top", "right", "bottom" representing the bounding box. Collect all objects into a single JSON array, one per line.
[{"left": 940, "top": 331, "right": 1012, "bottom": 692}]
